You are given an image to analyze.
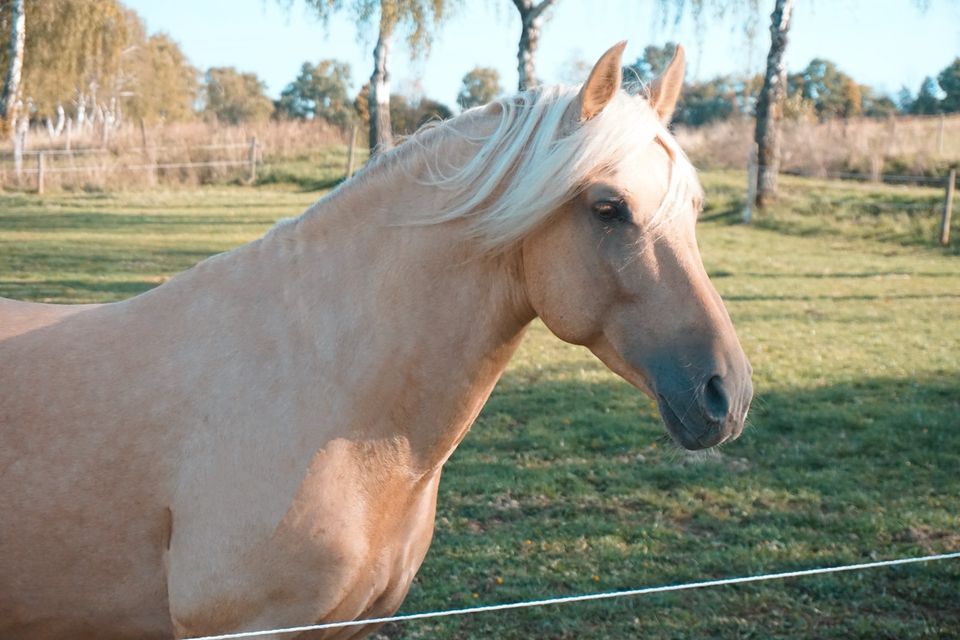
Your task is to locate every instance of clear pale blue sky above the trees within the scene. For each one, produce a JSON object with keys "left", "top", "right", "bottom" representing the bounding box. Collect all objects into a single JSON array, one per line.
[{"left": 125, "top": 0, "right": 960, "bottom": 106}]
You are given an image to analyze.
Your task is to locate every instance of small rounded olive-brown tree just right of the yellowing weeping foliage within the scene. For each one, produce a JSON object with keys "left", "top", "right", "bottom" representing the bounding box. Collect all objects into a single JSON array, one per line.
[{"left": 203, "top": 67, "right": 273, "bottom": 124}]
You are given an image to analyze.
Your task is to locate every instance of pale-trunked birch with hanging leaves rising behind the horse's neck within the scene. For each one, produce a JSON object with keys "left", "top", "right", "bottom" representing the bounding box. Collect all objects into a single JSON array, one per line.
[{"left": 306, "top": 0, "right": 451, "bottom": 153}]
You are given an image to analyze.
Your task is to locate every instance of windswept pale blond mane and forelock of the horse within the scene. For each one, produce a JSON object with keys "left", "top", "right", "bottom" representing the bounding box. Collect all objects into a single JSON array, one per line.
[{"left": 344, "top": 86, "right": 700, "bottom": 253}]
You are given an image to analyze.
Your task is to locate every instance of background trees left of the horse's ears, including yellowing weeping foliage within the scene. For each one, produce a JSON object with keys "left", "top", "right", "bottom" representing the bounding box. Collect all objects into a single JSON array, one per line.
[{"left": 0, "top": 0, "right": 502, "bottom": 136}]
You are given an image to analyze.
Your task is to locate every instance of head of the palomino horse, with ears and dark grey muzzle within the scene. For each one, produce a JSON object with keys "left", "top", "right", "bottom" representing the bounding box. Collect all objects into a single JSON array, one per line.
[{"left": 522, "top": 43, "right": 753, "bottom": 450}]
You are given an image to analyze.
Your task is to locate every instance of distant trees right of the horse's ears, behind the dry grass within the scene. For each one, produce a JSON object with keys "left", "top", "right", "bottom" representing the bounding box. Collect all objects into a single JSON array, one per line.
[{"left": 624, "top": 43, "right": 960, "bottom": 127}]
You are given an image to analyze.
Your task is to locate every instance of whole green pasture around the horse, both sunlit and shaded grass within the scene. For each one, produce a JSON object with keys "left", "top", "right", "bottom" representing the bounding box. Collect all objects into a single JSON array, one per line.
[{"left": 0, "top": 173, "right": 960, "bottom": 639}]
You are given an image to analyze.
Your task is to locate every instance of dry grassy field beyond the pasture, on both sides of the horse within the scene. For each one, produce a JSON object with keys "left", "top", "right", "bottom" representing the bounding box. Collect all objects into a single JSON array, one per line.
[{"left": 0, "top": 115, "right": 960, "bottom": 191}]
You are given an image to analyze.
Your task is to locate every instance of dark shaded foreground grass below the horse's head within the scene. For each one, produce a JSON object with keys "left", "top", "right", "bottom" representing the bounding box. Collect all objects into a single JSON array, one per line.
[{"left": 412, "top": 368, "right": 960, "bottom": 638}]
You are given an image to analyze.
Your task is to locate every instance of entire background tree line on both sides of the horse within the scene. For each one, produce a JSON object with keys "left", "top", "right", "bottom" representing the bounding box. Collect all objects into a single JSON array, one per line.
[{"left": 0, "top": 0, "right": 960, "bottom": 155}]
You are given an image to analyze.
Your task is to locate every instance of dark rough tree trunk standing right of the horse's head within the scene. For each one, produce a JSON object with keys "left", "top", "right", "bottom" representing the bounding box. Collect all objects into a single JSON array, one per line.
[{"left": 755, "top": 0, "right": 793, "bottom": 209}]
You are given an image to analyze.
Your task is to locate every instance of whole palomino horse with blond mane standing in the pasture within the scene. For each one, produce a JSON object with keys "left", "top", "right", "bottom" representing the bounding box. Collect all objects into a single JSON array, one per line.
[{"left": 0, "top": 43, "right": 752, "bottom": 639}]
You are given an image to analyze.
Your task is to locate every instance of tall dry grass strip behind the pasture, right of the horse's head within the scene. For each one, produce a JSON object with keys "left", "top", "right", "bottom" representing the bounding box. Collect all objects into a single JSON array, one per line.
[{"left": 677, "top": 114, "right": 960, "bottom": 177}]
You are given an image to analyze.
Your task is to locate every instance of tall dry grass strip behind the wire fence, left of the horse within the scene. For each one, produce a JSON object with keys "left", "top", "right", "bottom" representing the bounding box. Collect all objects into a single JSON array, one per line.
[{"left": 0, "top": 121, "right": 347, "bottom": 191}]
